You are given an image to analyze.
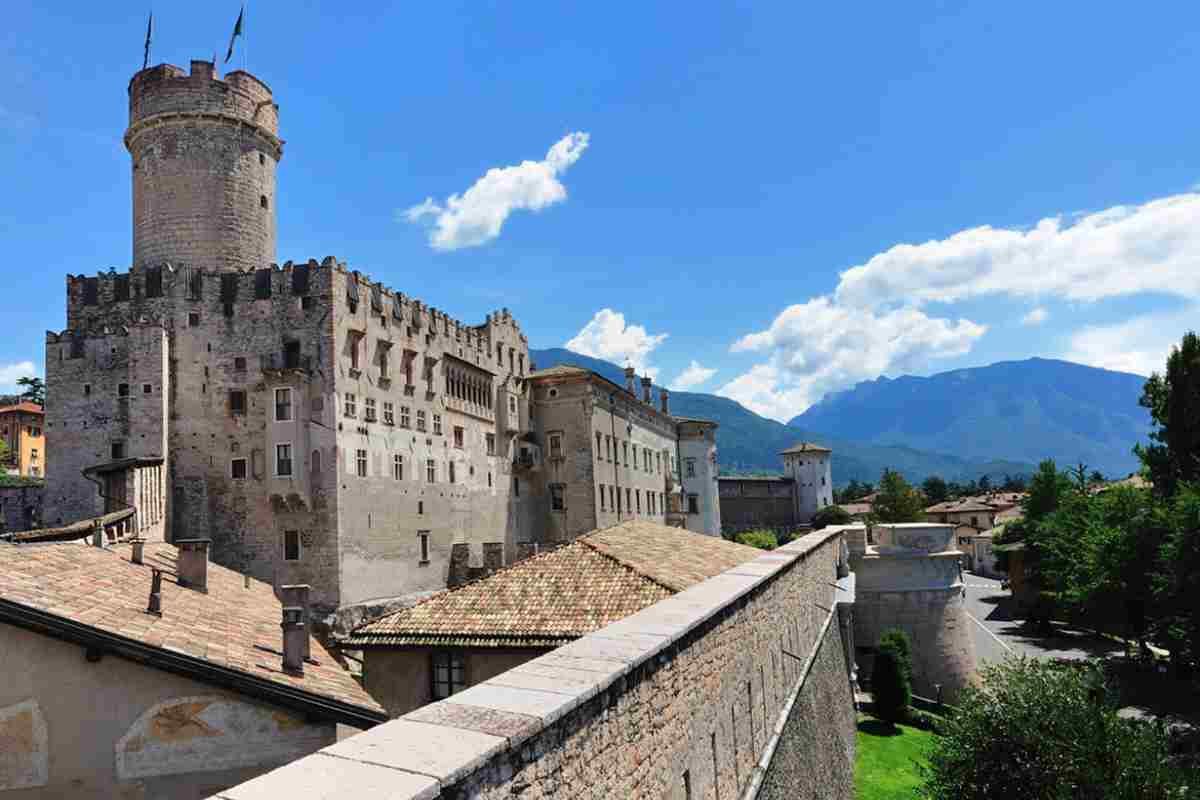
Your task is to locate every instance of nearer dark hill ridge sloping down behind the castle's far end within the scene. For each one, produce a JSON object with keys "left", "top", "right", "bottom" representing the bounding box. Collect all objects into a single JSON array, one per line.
[{"left": 530, "top": 348, "right": 1033, "bottom": 486}]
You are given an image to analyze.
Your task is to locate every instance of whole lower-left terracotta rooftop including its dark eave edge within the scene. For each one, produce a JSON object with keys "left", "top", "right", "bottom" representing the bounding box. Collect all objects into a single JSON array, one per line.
[{"left": 0, "top": 542, "right": 386, "bottom": 727}]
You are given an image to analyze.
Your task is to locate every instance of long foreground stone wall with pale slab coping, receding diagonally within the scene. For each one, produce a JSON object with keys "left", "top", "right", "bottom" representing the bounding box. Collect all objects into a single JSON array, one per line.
[{"left": 211, "top": 531, "right": 854, "bottom": 800}]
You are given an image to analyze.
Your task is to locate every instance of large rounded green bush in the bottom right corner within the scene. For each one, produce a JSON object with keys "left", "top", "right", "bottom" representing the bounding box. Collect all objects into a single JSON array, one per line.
[{"left": 920, "top": 658, "right": 1200, "bottom": 800}]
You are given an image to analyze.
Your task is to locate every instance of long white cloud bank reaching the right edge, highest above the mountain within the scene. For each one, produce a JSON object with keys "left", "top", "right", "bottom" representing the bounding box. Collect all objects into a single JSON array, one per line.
[{"left": 836, "top": 193, "right": 1200, "bottom": 307}]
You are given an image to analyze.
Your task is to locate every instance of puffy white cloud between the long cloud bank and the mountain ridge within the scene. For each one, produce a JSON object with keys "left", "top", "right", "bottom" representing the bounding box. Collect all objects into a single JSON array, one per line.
[{"left": 716, "top": 297, "right": 988, "bottom": 421}]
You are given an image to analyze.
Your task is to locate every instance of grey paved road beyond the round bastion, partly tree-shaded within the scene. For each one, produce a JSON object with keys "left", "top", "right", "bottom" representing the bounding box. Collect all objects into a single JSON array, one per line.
[{"left": 962, "top": 572, "right": 1121, "bottom": 666}]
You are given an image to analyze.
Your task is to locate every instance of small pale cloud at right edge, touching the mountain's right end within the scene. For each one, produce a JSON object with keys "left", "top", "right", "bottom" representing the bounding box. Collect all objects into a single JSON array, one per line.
[{"left": 1062, "top": 306, "right": 1200, "bottom": 375}]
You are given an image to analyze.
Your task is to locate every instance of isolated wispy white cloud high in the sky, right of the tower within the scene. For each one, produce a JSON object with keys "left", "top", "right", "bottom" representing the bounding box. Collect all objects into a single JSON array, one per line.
[{"left": 400, "top": 132, "right": 588, "bottom": 251}]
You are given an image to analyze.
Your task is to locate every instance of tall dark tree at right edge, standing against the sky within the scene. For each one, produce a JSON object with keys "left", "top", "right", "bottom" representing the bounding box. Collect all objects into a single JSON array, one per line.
[{"left": 1135, "top": 331, "right": 1200, "bottom": 497}]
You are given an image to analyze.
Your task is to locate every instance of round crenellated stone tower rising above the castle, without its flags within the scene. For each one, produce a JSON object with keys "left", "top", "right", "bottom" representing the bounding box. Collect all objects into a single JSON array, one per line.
[{"left": 125, "top": 61, "right": 283, "bottom": 271}]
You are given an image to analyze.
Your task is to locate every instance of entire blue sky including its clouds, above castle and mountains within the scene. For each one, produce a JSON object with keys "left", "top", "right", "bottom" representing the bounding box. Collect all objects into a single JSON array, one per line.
[{"left": 0, "top": 0, "right": 1200, "bottom": 419}]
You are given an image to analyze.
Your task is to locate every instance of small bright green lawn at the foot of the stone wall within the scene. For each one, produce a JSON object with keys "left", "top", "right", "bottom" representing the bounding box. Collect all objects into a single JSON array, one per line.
[{"left": 854, "top": 716, "right": 934, "bottom": 800}]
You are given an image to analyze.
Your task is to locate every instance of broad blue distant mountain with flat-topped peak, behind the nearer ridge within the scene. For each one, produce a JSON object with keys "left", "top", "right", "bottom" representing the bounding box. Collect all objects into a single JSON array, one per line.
[{"left": 788, "top": 359, "right": 1150, "bottom": 476}]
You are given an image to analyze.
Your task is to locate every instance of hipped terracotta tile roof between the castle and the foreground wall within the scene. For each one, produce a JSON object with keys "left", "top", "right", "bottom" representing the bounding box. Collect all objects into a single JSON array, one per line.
[{"left": 346, "top": 522, "right": 762, "bottom": 648}]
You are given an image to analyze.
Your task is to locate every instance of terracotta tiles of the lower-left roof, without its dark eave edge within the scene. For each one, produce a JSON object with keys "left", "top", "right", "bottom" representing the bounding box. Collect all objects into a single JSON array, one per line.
[{"left": 0, "top": 542, "right": 383, "bottom": 718}]
